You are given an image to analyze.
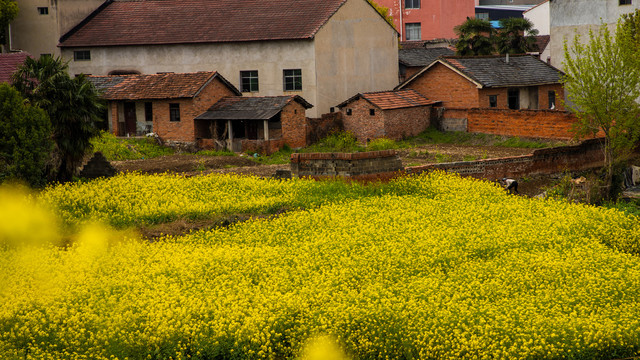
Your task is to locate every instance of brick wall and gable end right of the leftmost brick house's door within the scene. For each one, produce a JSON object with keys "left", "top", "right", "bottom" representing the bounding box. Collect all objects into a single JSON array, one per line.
[{"left": 153, "top": 78, "right": 235, "bottom": 142}]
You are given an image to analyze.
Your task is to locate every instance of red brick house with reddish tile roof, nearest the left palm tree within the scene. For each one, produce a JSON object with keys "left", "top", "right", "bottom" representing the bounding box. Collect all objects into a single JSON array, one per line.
[{"left": 89, "top": 71, "right": 241, "bottom": 143}]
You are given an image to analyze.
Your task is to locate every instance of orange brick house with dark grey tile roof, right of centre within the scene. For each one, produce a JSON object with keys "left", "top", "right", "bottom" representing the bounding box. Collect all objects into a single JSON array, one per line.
[{"left": 396, "top": 55, "right": 564, "bottom": 110}]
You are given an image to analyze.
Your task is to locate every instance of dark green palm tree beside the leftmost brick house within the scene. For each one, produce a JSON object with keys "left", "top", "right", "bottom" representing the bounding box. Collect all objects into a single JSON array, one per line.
[{"left": 13, "top": 56, "right": 103, "bottom": 182}]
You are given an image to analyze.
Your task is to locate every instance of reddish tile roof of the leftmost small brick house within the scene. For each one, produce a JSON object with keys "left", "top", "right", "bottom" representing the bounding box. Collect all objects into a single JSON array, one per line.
[{"left": 88, "top": 71, "right": 242, "bottom": 100}]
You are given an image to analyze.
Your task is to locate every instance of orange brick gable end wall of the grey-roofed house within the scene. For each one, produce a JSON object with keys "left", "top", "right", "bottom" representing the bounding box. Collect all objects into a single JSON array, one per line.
[{"left": 405, "top": 63, "right": 480, "bottom": 108}]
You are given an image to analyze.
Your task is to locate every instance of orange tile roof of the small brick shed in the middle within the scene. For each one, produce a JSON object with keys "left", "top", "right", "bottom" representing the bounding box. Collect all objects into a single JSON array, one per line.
[{"left": 338, "top": 89, "right": 439, "bottom": 110}]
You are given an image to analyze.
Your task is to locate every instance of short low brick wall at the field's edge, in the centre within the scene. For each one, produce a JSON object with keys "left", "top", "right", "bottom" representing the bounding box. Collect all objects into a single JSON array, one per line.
[{"left": 291, "top": 150, "right": 403, "bottom": 180}]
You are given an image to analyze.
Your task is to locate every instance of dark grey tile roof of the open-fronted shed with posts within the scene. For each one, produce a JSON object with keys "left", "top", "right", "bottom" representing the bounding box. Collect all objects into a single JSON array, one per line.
[{"left": 196, "top": 95, "right": 313, "bottom": 120}]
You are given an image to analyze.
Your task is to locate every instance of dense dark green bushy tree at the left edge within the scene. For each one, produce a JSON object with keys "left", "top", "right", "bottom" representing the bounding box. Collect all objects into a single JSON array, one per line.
[{"left": 0, "top": 83, "right": 53, "bottom": 187}]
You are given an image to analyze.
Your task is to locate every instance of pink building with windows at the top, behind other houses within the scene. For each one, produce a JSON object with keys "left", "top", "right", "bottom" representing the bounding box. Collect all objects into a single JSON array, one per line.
[{"left": 374, "top": 0, "right": 477, "bottom": 41}]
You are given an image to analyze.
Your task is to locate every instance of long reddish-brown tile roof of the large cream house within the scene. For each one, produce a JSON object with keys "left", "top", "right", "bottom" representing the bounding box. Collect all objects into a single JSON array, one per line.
[{"left": 60, "top": 0, "right": 347, "bottom": 47}]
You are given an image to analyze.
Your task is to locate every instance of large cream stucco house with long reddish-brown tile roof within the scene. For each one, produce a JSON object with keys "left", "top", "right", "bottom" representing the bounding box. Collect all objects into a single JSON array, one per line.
[{"left": 59, "top": 0, "right": 398, "bottom": 117}]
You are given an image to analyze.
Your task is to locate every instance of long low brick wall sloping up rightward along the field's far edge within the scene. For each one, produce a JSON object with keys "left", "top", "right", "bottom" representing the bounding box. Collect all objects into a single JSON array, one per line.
[{"left": 405, "top": 139, "right": 604, "bottom": 180}]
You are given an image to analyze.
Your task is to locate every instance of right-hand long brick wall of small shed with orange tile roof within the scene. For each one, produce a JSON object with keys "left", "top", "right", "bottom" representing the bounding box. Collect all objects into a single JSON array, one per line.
[{"left": 384, "top": 106, "right": 431, "bottom": 140}]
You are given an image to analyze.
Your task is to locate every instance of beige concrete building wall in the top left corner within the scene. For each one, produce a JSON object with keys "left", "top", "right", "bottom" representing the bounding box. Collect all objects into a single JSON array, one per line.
[{"left": 10, "top": 0, "right": 104, "bottom": 57}]
